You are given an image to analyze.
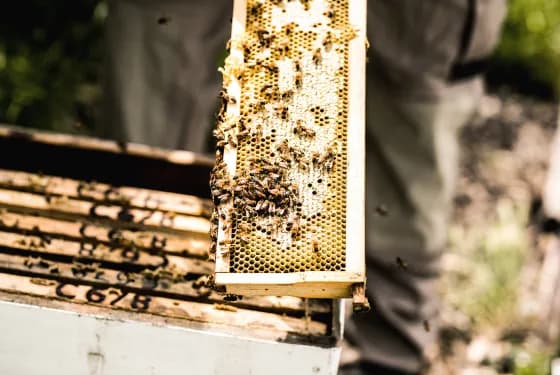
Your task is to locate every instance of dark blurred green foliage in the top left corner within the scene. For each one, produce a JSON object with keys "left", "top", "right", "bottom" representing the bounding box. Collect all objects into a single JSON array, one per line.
[{"left": 0, "top": 0, "right": 106, "bottom": 129}]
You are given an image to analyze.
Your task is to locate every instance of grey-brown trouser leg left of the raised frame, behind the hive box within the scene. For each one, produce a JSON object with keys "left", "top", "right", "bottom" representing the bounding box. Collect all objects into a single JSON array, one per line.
[{"left": 101, "top": 0, "right": 232, "bottom": 152}]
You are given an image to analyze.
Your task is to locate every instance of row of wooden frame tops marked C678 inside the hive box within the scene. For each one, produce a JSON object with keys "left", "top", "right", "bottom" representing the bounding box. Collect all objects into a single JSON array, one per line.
[{"left": 0, "top": 169, "right": 331, "bottom": 335}]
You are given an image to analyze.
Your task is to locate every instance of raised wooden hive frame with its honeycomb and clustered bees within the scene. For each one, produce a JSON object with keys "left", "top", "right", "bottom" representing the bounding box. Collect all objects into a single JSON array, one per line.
[{"left": 212, "top": 0, "right": 367, "bottom": 298}]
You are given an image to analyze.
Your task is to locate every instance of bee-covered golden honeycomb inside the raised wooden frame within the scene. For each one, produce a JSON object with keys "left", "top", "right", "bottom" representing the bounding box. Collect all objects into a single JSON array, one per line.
[{"left": 211, "top": 0, "right": 355, "bottom": 273}]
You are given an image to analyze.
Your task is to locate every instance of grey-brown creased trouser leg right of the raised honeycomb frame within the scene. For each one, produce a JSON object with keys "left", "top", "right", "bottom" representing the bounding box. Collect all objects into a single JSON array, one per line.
[{"left": 345, "top": 0, "right": 503, "bottom": 373}]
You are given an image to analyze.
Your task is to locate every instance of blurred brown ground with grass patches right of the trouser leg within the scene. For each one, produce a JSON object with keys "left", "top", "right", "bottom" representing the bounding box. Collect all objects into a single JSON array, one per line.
[{"left": 430, "top": 92, "right": 560, "bottom": 375}]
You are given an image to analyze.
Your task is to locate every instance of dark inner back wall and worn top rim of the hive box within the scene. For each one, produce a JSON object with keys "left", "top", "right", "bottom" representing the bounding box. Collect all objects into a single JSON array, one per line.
[{"left": 0, "top": 125, "right": 212, "bottom": 198}]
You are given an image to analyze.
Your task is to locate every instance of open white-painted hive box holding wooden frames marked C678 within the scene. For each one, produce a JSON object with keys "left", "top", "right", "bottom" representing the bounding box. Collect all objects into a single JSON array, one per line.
[{"left": 0, "top": 127, "right": 340, "bottom": 375}]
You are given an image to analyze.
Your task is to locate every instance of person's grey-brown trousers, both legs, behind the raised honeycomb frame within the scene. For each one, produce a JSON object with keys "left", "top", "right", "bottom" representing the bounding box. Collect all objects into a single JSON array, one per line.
[{"left": 98, "top": 0, "right": 505, "bottom": 371}]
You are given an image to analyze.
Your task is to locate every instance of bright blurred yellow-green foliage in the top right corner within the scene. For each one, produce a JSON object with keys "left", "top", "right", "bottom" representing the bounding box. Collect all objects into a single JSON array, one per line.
[{"left": 488, "top": 0, "right": 560, "bottom": 97}]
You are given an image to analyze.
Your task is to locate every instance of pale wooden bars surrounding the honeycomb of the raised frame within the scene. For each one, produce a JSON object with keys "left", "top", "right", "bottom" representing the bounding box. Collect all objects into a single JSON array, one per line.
[{"left": 215, "top": 0, "right": 367, "bottom": 303}]
